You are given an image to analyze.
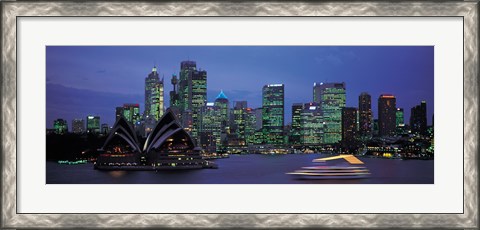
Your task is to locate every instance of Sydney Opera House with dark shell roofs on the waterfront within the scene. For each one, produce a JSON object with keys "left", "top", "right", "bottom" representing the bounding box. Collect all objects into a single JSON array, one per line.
[{"left": 94, "top": 109, "right": 216, "bottom": 170}]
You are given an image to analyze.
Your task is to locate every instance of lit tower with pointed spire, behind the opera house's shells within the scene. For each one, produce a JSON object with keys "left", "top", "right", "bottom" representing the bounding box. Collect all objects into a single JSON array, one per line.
[{"left": 143, "top": 66, "right": 164, "bottom": 121}]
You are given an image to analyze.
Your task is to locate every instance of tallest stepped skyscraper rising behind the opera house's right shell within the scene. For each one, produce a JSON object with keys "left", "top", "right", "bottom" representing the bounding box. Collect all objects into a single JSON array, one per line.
[{"left": 178, "top": 61, "right": 207, "bottom": 141}]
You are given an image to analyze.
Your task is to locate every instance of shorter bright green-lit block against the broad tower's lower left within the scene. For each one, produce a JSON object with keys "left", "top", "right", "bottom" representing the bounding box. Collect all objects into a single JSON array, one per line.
[{"left": 300, "top": 102, "right": 324, "bottom": 145}]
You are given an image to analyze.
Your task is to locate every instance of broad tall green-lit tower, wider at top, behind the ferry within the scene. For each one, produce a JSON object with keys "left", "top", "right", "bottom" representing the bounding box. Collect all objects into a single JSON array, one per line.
[{"left": 313, "top": 82, "right": 346, "bottom": 144}]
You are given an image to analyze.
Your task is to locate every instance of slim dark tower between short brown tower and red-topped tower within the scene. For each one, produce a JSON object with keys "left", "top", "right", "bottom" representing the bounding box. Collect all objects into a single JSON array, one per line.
[{"left": 358, "top": 92, "right": 373, "bottom": 137}]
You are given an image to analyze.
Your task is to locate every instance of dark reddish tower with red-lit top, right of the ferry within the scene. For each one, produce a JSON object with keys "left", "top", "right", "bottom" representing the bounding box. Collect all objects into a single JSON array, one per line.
[{"left": 378, "top": 94, "right": 397, "bottom": 136}]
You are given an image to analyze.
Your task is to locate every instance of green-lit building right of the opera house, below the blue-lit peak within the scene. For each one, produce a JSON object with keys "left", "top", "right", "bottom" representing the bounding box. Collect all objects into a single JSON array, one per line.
[{"left": 199, "top": 102, "right": 222, "bottom": 153}]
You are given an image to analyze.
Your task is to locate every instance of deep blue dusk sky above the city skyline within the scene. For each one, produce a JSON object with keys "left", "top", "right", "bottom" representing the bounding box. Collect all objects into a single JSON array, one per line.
[{"left": 46, "top": 46, "right": 434, "bottom": 129}]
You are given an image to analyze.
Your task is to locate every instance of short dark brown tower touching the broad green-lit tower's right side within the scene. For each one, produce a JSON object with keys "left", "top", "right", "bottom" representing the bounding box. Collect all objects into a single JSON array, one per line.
[{"left": 342, "top": 107, "right": 358, "bottom": 148}]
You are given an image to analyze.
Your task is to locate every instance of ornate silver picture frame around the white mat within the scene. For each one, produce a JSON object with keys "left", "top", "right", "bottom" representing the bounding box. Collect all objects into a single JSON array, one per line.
[{"left": 1, "top": 1, "right": 479, "bottom": 228}]
